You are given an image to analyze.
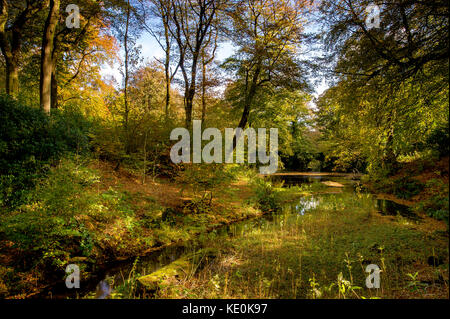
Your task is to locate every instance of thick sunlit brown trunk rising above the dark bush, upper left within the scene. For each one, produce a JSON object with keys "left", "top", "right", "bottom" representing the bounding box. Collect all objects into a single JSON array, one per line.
[{"left": 39, "top": 0, "right": 60, "bottom": 114}]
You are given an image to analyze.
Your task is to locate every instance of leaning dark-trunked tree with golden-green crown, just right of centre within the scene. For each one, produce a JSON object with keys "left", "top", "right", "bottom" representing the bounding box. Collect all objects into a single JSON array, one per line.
[{"left": 224, "top": 0, "right": 306, "bottom": 132}]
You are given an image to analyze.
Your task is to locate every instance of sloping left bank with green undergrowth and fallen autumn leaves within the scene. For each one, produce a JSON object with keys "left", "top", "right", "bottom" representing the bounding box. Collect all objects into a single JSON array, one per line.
[{"left": 0, "top": 157, "right": 261, "bottom": 297}]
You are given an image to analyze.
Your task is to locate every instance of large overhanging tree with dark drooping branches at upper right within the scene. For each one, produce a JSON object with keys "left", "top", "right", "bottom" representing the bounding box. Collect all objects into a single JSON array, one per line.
[{"left": 319, "top": 0, "right": 448, "bottom": 174}]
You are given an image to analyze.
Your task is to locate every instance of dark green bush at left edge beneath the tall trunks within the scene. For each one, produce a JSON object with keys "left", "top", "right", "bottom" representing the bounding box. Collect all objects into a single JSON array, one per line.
[{"left": 0, "top": 95, "right": 91, "bottom": 207}]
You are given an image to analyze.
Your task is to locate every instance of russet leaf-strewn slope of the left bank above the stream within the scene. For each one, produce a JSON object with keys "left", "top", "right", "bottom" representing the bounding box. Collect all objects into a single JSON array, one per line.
[{"left": 0, "top": 160, "right": 264, "bottom": 298}]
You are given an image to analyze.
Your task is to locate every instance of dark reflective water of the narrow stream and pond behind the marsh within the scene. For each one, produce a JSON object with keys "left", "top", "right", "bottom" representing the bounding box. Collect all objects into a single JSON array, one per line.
[{"left": 41, "top": 174, "right": 420, "bottom": 299}]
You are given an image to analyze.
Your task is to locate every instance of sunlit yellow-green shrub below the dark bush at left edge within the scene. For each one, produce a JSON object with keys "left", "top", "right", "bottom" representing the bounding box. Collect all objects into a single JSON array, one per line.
[{"left": 0, "top": 160, "right": 99, "bottom": 267}]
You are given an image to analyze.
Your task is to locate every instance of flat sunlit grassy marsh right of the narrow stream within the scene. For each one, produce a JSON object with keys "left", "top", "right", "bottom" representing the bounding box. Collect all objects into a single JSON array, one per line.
[{"left": 150, "top": 195, "right": 448, "bottom": 298}]
